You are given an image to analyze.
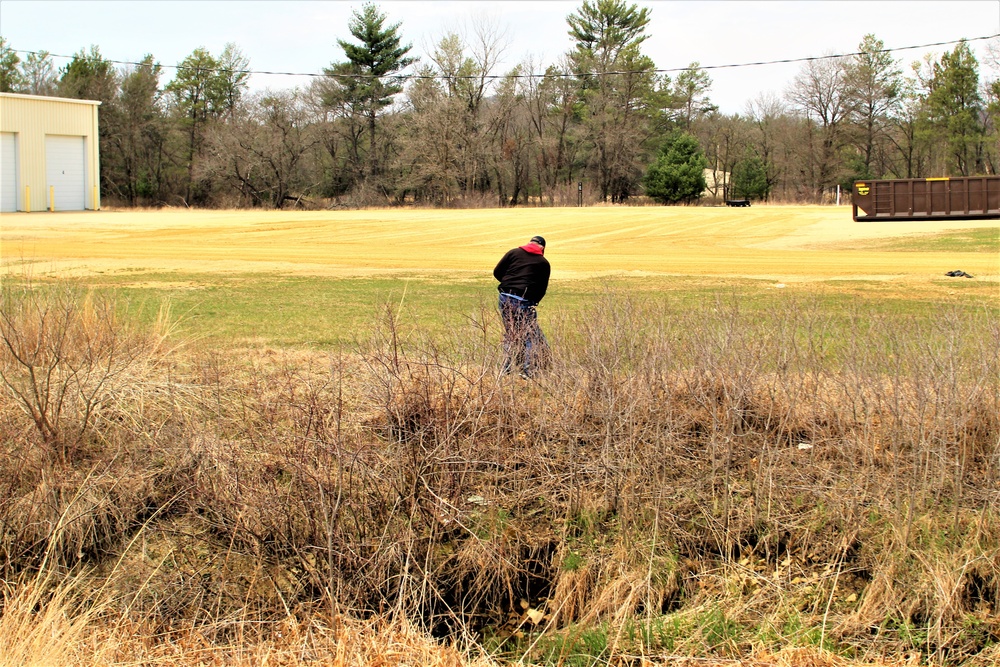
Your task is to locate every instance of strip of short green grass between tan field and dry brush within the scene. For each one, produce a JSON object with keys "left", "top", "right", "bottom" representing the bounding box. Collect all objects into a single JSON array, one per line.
[{"left": 6, "top": 271, "right": 1000, "bottom": 349}]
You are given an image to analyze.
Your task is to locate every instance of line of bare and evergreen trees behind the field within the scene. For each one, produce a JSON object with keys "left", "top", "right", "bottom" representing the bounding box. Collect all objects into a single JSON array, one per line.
[{"left": 0, "top": 0, "right": 1000, "bottom": 208}]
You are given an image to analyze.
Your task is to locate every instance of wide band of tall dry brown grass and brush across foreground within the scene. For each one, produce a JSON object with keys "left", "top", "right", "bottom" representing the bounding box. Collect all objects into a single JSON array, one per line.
[{"left": 0, "top": 290, "right": 1000, "bottom": 665}]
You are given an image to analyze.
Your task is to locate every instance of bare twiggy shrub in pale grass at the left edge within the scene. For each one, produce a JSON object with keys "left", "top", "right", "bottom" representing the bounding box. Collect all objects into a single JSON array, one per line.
[{"left": 0, "top": 282, "right": 174, "bottom": 463}]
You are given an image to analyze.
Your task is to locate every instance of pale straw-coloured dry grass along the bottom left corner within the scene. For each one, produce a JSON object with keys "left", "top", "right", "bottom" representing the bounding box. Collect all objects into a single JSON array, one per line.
[{"left": 0, "top": 577, "right": 495, "bottom": 667}]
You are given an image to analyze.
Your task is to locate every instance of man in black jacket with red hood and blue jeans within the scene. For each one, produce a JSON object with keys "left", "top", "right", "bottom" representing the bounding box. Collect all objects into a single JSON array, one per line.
[{"left": 493, "top": 236, "right": 551, "bottom": 378}]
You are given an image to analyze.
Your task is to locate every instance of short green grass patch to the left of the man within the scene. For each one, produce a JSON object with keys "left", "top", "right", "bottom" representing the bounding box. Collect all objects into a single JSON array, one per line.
[{"left": 58, "top": 274, "right": 492, "bottom": 349}]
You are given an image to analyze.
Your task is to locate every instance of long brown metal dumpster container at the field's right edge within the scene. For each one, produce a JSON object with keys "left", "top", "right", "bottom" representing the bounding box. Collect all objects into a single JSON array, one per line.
[{"left": 851, "top": 176, "right": 1000, "bottom": 222}]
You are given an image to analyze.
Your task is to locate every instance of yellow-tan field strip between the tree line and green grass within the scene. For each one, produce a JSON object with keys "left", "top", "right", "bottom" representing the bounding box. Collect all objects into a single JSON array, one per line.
[{"left": 0, "top": 206, "right": 1000, "bottom": 292}]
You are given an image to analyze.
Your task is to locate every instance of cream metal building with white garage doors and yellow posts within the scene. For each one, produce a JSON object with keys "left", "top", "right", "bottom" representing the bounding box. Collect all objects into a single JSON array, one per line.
[{"left": 0, "top": 93, "right": 101, "bottom": 213}]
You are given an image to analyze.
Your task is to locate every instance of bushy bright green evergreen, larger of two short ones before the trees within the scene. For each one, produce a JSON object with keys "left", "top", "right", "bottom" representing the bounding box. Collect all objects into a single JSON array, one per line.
[{"left": 645, "top": 133, "right": 707, "bottom": 204}]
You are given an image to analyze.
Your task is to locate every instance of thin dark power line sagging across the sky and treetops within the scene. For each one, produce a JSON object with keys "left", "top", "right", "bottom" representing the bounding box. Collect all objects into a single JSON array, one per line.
[{"left": 11, "top": 33, "right": 1000, "bottom": 81}]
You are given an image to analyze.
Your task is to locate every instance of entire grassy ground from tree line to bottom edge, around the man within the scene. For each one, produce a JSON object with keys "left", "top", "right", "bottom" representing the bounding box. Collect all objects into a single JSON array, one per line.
[{"left": 0, "top": 206, "right": 1000, "bottom": 667}]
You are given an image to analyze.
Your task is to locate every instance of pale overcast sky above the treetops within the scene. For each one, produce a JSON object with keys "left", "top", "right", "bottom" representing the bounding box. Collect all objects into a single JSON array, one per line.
[{"left": 0, "top": 0, "right": 1000, "bottom": 113}]
